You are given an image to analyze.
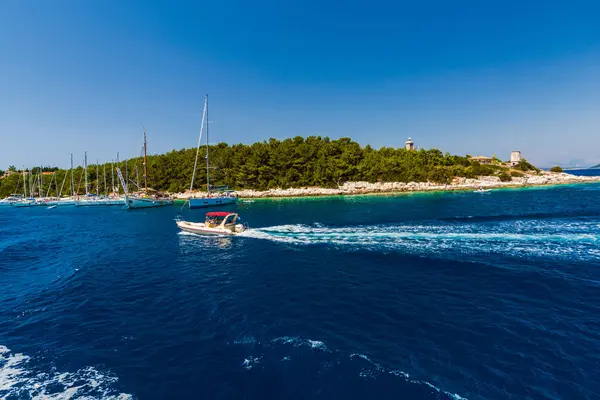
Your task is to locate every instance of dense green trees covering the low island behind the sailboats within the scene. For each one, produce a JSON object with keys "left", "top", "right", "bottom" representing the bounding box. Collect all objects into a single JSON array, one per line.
[{"left": 0, "top": 136, "right": 535, "bottom": 196}]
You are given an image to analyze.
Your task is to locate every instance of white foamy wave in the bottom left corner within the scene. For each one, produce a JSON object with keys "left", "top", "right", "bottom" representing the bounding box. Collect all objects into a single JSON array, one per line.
[{"left": 0, "top": 345, "right": 133, "bottom": 400}]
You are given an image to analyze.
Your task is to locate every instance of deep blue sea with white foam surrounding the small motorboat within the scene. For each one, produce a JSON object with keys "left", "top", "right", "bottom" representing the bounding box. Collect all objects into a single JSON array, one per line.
[{"left": 0, "top": 184, "right": 600, "bottom": 399}]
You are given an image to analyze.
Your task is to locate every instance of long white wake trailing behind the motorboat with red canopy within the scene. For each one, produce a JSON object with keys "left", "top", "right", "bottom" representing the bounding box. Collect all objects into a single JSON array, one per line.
[{"left": 241, "top": 220, "right": 600, "bottom": 261}]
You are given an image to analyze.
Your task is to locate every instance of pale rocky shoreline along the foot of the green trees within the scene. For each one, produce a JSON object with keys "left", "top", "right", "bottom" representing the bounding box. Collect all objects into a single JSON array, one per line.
[{"left": 173, "top": 171, "right": 600, "bottom": 199}]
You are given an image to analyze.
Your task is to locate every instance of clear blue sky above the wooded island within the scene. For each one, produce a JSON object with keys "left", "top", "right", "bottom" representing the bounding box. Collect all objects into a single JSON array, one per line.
[{"left": 0, "top": 0, "right": 600, "bottom": 169}]
